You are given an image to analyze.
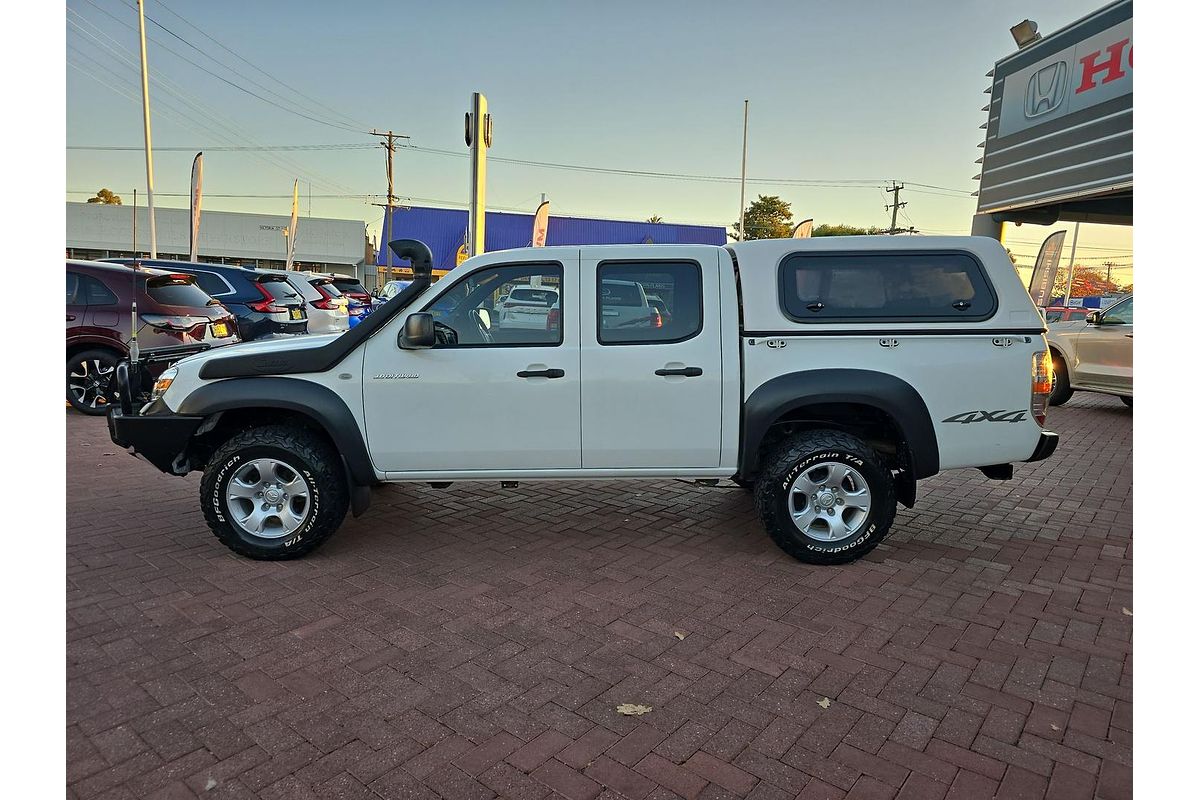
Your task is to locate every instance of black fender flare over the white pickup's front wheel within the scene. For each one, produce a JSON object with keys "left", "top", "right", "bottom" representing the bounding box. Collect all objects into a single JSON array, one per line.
[{"left": 176, "top": 377, "right": 378, "bottom": 489}]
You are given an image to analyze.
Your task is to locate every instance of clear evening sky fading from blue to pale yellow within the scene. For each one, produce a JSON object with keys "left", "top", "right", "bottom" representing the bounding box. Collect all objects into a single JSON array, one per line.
[{"left": 66, "top": 0, "right": 1133, "bottom": 281}]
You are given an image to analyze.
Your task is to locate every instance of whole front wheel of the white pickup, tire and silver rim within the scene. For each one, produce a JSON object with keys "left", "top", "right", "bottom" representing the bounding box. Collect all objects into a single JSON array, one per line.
[{"left": 200, "top": 425, "right": 349, "bottom": 560}]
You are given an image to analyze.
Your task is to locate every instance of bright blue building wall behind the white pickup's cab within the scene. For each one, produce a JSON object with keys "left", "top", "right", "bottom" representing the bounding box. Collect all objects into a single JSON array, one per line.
[{"left": 378, "top": 206, "right": 726, "bottom": 279}]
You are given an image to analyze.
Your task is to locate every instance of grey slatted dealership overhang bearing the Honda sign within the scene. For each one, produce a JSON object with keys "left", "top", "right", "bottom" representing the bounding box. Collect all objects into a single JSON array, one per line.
[{"left": 977, "top": 0, "right": 1133, "bottom": 224}]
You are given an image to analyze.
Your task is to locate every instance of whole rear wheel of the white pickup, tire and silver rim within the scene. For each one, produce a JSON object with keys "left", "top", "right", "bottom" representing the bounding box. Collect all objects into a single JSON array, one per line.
[{"left": 755, "top": 431, "right": 896, "bottom": 564}]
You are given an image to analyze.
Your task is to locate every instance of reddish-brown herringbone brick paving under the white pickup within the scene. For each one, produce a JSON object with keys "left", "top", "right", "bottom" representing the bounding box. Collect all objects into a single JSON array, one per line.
[{"left": 66, "top": 395, "right": 1133, "bottom": 800}]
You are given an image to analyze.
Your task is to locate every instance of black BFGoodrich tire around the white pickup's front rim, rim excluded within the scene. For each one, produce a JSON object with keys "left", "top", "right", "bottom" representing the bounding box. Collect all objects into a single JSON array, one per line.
[{"left": 200, "top": 425, "right": 350, "bottom": 561}]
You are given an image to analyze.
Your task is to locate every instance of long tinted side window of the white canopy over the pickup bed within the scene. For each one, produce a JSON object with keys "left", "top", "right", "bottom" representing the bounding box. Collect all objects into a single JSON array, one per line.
[{"left": 779, "top": 251, "right": 996, "bottom": 323}]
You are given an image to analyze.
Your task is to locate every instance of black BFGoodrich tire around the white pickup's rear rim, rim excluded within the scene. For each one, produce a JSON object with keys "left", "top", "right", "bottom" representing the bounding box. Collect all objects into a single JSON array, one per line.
[{"left": 755, "top": 431, "right": 896, "bottom": 564}]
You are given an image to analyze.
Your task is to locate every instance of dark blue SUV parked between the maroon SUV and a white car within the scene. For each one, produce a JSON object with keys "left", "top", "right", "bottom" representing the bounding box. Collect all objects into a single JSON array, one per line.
[{"left": 106, "top": 258, "right": 308, "bottom": 342}]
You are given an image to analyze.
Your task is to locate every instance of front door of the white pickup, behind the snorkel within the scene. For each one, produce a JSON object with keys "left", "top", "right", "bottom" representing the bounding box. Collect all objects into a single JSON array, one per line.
[{"left": 362, "top": 248, "right": 580, "bottom": 473}]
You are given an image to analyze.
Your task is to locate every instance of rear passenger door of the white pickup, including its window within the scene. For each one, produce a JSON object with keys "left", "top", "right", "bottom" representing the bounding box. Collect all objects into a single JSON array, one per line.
[{"left": 580, "top": 255, "right": 722, "bottom": 469}]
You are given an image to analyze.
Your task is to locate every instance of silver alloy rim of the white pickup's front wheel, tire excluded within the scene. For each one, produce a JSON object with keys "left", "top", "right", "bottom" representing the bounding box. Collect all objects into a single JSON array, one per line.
[{"left": 226, "top": 458, "right": 311, "bottom": 539}]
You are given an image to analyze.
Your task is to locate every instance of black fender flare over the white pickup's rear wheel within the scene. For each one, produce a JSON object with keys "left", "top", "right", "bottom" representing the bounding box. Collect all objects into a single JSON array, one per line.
[{"left": 738, "top": 369, "right": 940, "bottom": 479}]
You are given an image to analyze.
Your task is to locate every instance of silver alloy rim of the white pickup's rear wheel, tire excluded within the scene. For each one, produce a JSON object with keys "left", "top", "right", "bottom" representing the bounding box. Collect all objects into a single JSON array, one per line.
[{"left": 787, "top": 462, "right": 871, "bottom": 542}]
